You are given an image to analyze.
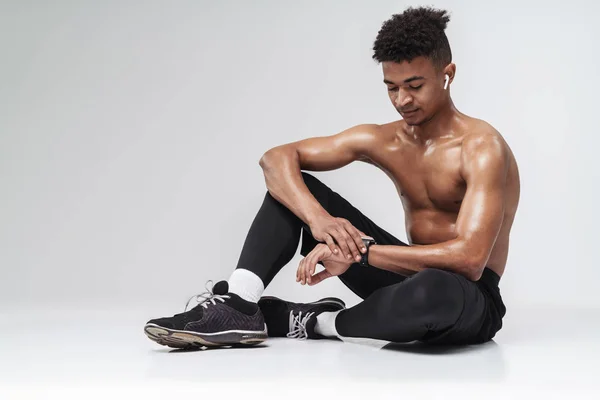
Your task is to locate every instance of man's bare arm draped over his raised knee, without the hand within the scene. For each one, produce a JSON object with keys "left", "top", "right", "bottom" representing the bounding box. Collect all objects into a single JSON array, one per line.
[{"left": 259, "top": 124, "right": 380, "bottom": 225}]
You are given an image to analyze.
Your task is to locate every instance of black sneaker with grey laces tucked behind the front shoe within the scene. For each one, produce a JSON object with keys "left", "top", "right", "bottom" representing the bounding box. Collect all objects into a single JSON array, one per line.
[{"left": 258, "top": 296, "right": 346, "bottom": 339}]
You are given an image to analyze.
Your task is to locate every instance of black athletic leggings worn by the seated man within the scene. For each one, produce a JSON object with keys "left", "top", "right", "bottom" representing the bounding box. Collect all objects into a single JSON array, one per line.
[{"left": 237, "top": 172, "right": 506, "bottom": 344}]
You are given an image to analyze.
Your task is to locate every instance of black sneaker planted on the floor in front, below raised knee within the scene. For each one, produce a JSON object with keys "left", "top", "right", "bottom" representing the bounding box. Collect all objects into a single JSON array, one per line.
[{"left": 144, "top": 281, "right": 268, "bottom": 348}]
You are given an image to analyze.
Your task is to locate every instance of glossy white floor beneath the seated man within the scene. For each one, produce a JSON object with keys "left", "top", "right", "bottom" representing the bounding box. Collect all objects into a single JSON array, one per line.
[{"left": 0, "top": 307, "right": 600, "bottom": 399}]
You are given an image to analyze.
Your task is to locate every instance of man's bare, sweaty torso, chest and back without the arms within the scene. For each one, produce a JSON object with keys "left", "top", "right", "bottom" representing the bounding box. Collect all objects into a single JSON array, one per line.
[{"left": 363, "top": 114, "right": 520, "bottom": 276}]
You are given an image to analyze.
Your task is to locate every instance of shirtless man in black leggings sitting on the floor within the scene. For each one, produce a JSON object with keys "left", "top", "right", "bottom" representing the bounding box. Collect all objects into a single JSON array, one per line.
[{"left": 144, "top": 7, "right": 519, "bottom": 347}]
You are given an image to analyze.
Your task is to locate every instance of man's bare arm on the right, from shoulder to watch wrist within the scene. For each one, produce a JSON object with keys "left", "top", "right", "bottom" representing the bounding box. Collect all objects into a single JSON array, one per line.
[{"left": 368, "top": 135, "right": 509, "bottom": 281}]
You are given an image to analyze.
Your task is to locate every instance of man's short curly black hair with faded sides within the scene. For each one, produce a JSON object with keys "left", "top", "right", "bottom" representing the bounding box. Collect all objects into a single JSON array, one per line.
[{"left": 373, "top": 7, "right": 452, "bottom": 71}]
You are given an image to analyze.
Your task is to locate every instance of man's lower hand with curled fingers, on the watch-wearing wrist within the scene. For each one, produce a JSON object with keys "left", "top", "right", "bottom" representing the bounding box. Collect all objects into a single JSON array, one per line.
[{"left": 296, "top": 241, "right": 354, "bottom": 286}]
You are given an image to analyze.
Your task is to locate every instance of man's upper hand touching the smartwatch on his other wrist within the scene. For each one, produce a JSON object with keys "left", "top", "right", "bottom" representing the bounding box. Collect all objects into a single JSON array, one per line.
[{"left": 309, "top": 215, "right": 370, "bottom": 263}]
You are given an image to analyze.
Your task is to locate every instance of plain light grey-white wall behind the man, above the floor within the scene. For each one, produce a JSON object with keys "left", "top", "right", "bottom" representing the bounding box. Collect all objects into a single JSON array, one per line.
[{"left": 0, "top": 0, "right": 600, "bottom": 312}]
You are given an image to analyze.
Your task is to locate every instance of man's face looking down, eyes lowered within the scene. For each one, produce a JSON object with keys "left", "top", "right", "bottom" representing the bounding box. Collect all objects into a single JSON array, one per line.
[{"left": 382, "top": 57, "right": 452, "bottom": 125}]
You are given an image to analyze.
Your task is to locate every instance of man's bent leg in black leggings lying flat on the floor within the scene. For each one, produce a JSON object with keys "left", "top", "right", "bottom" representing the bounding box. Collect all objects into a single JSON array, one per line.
[{"left": 335, "top": 268, "right": 485, "bottom": 344}]
